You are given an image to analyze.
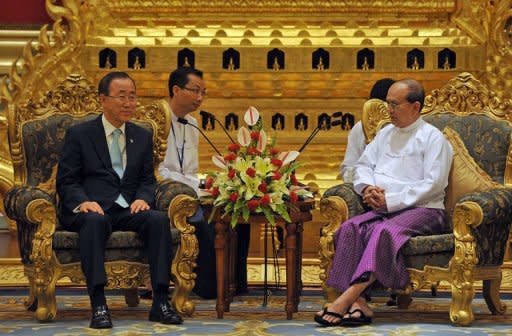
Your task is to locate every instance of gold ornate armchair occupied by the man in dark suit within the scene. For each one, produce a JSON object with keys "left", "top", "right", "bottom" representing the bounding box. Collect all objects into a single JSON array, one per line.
[{"left": 4, "top": 75, "right": 198, "bottom": 321}]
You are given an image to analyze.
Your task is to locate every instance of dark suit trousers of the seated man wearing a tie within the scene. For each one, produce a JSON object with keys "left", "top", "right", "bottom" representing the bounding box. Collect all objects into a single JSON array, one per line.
[{"left": 65, "top": 204, "right": 172, "bottom": 295}]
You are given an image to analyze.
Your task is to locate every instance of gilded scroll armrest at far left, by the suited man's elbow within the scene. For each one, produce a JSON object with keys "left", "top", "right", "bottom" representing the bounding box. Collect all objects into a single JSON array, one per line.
[{"left": 4, "top": 186, "right": 57, "bottom": 264}]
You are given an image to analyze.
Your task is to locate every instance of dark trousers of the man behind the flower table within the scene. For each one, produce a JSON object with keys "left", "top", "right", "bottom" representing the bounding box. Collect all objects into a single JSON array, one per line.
[{"left": 188, "top": 206, "right": 251, "bottom": 299}]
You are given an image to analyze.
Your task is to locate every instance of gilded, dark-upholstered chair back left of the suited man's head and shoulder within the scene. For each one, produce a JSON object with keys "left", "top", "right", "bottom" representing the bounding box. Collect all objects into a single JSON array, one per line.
[{"left": 8, "top": 75, "right": 101, "bottom": 191}]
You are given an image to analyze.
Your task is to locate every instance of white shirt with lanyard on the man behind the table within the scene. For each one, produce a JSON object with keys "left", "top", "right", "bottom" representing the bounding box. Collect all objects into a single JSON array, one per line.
[{"left": 158, "top": 111, "right": 199, "bottom": 193}]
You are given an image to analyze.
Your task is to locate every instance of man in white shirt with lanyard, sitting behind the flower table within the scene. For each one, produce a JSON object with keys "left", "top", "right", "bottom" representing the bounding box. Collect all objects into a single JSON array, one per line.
[{"left": 158, "top": 67, "right": 217, "bottom": 299}]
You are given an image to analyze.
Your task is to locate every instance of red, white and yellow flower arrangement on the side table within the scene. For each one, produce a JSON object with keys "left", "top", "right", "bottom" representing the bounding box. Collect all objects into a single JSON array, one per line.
[{"left": 205, "top": 106, "right": 313, "bottom": 227}]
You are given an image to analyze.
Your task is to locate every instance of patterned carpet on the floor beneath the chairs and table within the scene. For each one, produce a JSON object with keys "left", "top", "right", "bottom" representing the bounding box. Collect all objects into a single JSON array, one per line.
[{"left": 0, "top": 289, "right": 512, "bottom": 336}]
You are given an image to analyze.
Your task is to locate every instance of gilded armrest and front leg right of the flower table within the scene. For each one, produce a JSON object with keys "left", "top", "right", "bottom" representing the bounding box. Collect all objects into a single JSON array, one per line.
[{"left": 319, "top": 183, "right": 366, "bottom": 298}]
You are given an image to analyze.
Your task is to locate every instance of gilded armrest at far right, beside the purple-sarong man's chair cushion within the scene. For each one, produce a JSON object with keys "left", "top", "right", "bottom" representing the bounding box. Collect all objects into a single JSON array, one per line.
[{"left": 453, "top": 188, "right": 512, "bottom": 266}]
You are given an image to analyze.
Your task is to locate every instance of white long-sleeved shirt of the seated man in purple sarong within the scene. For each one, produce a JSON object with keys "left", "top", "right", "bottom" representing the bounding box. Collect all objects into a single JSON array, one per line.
[{"left": 354, "top": 117, "right": 453, "bottom": 212}]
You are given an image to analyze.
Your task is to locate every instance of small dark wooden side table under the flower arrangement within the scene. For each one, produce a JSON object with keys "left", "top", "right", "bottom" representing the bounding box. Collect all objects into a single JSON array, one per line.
[{"left": 202, "top": 199, "right": 315, "bottom": 320}]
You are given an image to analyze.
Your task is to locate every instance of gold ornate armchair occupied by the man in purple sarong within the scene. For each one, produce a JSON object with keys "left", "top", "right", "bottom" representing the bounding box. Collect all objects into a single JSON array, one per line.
[{"left": 320, "top": 73, "right": 512, "bottom": 325}]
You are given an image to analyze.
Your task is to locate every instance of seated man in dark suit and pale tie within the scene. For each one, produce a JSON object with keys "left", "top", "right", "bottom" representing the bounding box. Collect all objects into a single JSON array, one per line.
[{"left": 57, "top": 72, "right": 183, "bottom": 328}]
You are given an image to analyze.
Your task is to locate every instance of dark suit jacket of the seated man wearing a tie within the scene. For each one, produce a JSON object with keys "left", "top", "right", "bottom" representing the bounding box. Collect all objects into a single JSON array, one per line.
[{"left": 57, "top": 115, "right": 156, "bottom": 225}]
